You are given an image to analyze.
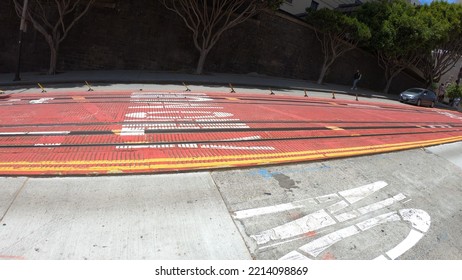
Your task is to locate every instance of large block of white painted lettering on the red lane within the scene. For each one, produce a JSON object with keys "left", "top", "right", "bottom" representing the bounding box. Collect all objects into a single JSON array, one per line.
[{"left": 116, "top": 92, "right": 275, "bottom": 151}]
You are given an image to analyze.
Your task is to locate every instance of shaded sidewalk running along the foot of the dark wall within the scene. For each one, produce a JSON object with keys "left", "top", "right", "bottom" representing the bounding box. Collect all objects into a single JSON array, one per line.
[{"left": 0, "top": 70, "right": 397, "bottom": 100}]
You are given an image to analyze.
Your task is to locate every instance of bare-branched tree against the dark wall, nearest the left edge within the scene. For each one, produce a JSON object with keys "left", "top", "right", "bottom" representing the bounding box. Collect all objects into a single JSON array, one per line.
[{"left": 13, "top": 0, "right": 95, "bottom": 75}]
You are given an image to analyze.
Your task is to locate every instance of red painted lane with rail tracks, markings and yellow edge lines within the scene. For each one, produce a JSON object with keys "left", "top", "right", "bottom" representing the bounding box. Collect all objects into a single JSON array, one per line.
[{"left": 0, "top": 91, "right": 462, "bottom": 175}]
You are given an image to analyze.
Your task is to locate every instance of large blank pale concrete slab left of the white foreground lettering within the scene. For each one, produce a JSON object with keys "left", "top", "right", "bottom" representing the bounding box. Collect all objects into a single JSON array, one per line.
[{"left": 0, "top": 173, "right": 250, "bottom": 259}]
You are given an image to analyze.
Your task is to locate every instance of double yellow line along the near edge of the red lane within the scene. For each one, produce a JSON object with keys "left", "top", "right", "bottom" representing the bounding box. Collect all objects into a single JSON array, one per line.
[{"left": 0, "top": 136, "right": 462, "bottom": 172}]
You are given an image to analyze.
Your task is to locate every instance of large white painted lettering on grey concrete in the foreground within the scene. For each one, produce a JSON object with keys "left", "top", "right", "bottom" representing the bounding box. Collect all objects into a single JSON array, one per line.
[{"left": 234, "top": 181, "right": 431, "bottom": 260}]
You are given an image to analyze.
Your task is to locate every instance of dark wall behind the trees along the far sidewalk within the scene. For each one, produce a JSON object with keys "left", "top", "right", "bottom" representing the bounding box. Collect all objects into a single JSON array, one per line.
[{"left": 0, "top": 0, "right": 421, "bottom": 92}]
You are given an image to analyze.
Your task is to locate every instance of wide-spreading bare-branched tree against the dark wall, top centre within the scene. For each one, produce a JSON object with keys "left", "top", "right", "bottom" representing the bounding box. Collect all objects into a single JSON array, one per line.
[{"left": 159, "top": 0, "right": 282, "bottom": 74}]
